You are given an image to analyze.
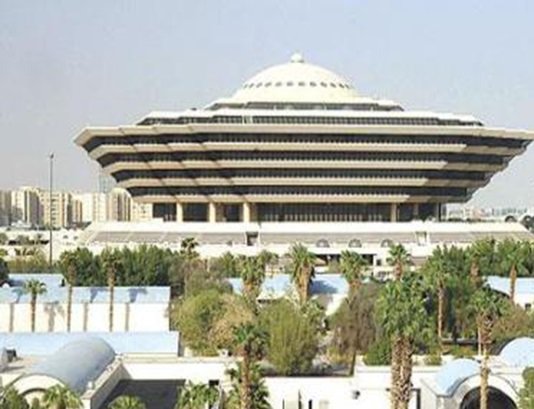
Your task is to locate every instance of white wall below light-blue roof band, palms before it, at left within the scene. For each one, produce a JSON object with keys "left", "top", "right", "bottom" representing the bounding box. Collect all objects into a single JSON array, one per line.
[{"left": 0, "top": 303, "right": 169, "bottom": 332}]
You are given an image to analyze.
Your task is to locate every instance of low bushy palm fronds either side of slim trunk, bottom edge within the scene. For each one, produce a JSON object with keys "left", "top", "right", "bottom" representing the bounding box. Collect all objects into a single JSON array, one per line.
[{"left": 224, "top": 363, "right": 271, "bottom": 409}]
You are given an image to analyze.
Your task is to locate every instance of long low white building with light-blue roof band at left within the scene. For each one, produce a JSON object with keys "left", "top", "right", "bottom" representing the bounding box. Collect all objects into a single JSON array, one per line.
[{"left": 0, "top": 274, "right": 170, "bottom": 333}]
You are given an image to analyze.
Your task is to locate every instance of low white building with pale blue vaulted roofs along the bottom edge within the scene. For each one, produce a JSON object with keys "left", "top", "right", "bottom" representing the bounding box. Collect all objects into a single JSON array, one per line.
[{"left": 0, "top": 333, "right": 534, "bottom": 409}]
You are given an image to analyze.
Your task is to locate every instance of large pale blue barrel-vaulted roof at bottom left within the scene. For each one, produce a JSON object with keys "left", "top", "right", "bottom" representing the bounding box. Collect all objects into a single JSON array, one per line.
[{"left": 26, "top": 337, "right": 115, "bottom": 393}]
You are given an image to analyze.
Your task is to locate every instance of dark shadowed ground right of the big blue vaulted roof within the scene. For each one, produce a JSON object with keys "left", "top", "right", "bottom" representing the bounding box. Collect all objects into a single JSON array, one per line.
[{"left": 99, "top": 380, "right": 184, "bottom": 409}]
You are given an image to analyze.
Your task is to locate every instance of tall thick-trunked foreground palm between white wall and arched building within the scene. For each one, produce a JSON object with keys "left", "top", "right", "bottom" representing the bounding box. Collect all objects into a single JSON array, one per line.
[{"left": 376, "top": 274, "right": 428, "bottom": 409}]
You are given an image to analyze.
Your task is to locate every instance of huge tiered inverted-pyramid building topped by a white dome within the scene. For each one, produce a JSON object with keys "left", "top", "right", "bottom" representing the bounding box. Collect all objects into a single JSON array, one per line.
[{"left": 76, "top": 55, "right": 534, "bottom": 223}]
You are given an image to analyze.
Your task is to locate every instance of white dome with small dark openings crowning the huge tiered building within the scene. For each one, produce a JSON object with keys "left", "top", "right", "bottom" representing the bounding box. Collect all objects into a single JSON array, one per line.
[{"left": 231, "top": 54, "right": 358, "bottom": 103}]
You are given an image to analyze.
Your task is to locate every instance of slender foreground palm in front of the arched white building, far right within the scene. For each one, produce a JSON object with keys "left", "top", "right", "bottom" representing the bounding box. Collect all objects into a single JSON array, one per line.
[{"left": 472, "top": 287, "right": 506, "bottom": 409}]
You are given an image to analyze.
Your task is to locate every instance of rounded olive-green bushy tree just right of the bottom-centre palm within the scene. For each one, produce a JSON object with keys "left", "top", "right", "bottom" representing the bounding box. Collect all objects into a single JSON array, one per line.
[{"left": 260, "top": 300, "right": 319, "bottom": 376}]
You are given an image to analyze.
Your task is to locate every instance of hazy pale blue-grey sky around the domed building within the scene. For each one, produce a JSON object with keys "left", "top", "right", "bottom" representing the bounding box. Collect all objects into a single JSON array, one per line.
[{"left": 0, "top": 0, "right": 534, "bottom": 206}]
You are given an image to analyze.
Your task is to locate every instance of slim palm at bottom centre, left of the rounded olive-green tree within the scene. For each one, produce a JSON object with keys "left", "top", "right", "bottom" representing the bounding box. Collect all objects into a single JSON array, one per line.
[{"left": 234, "top": 324, "right": 265, "bottom": 409}]
